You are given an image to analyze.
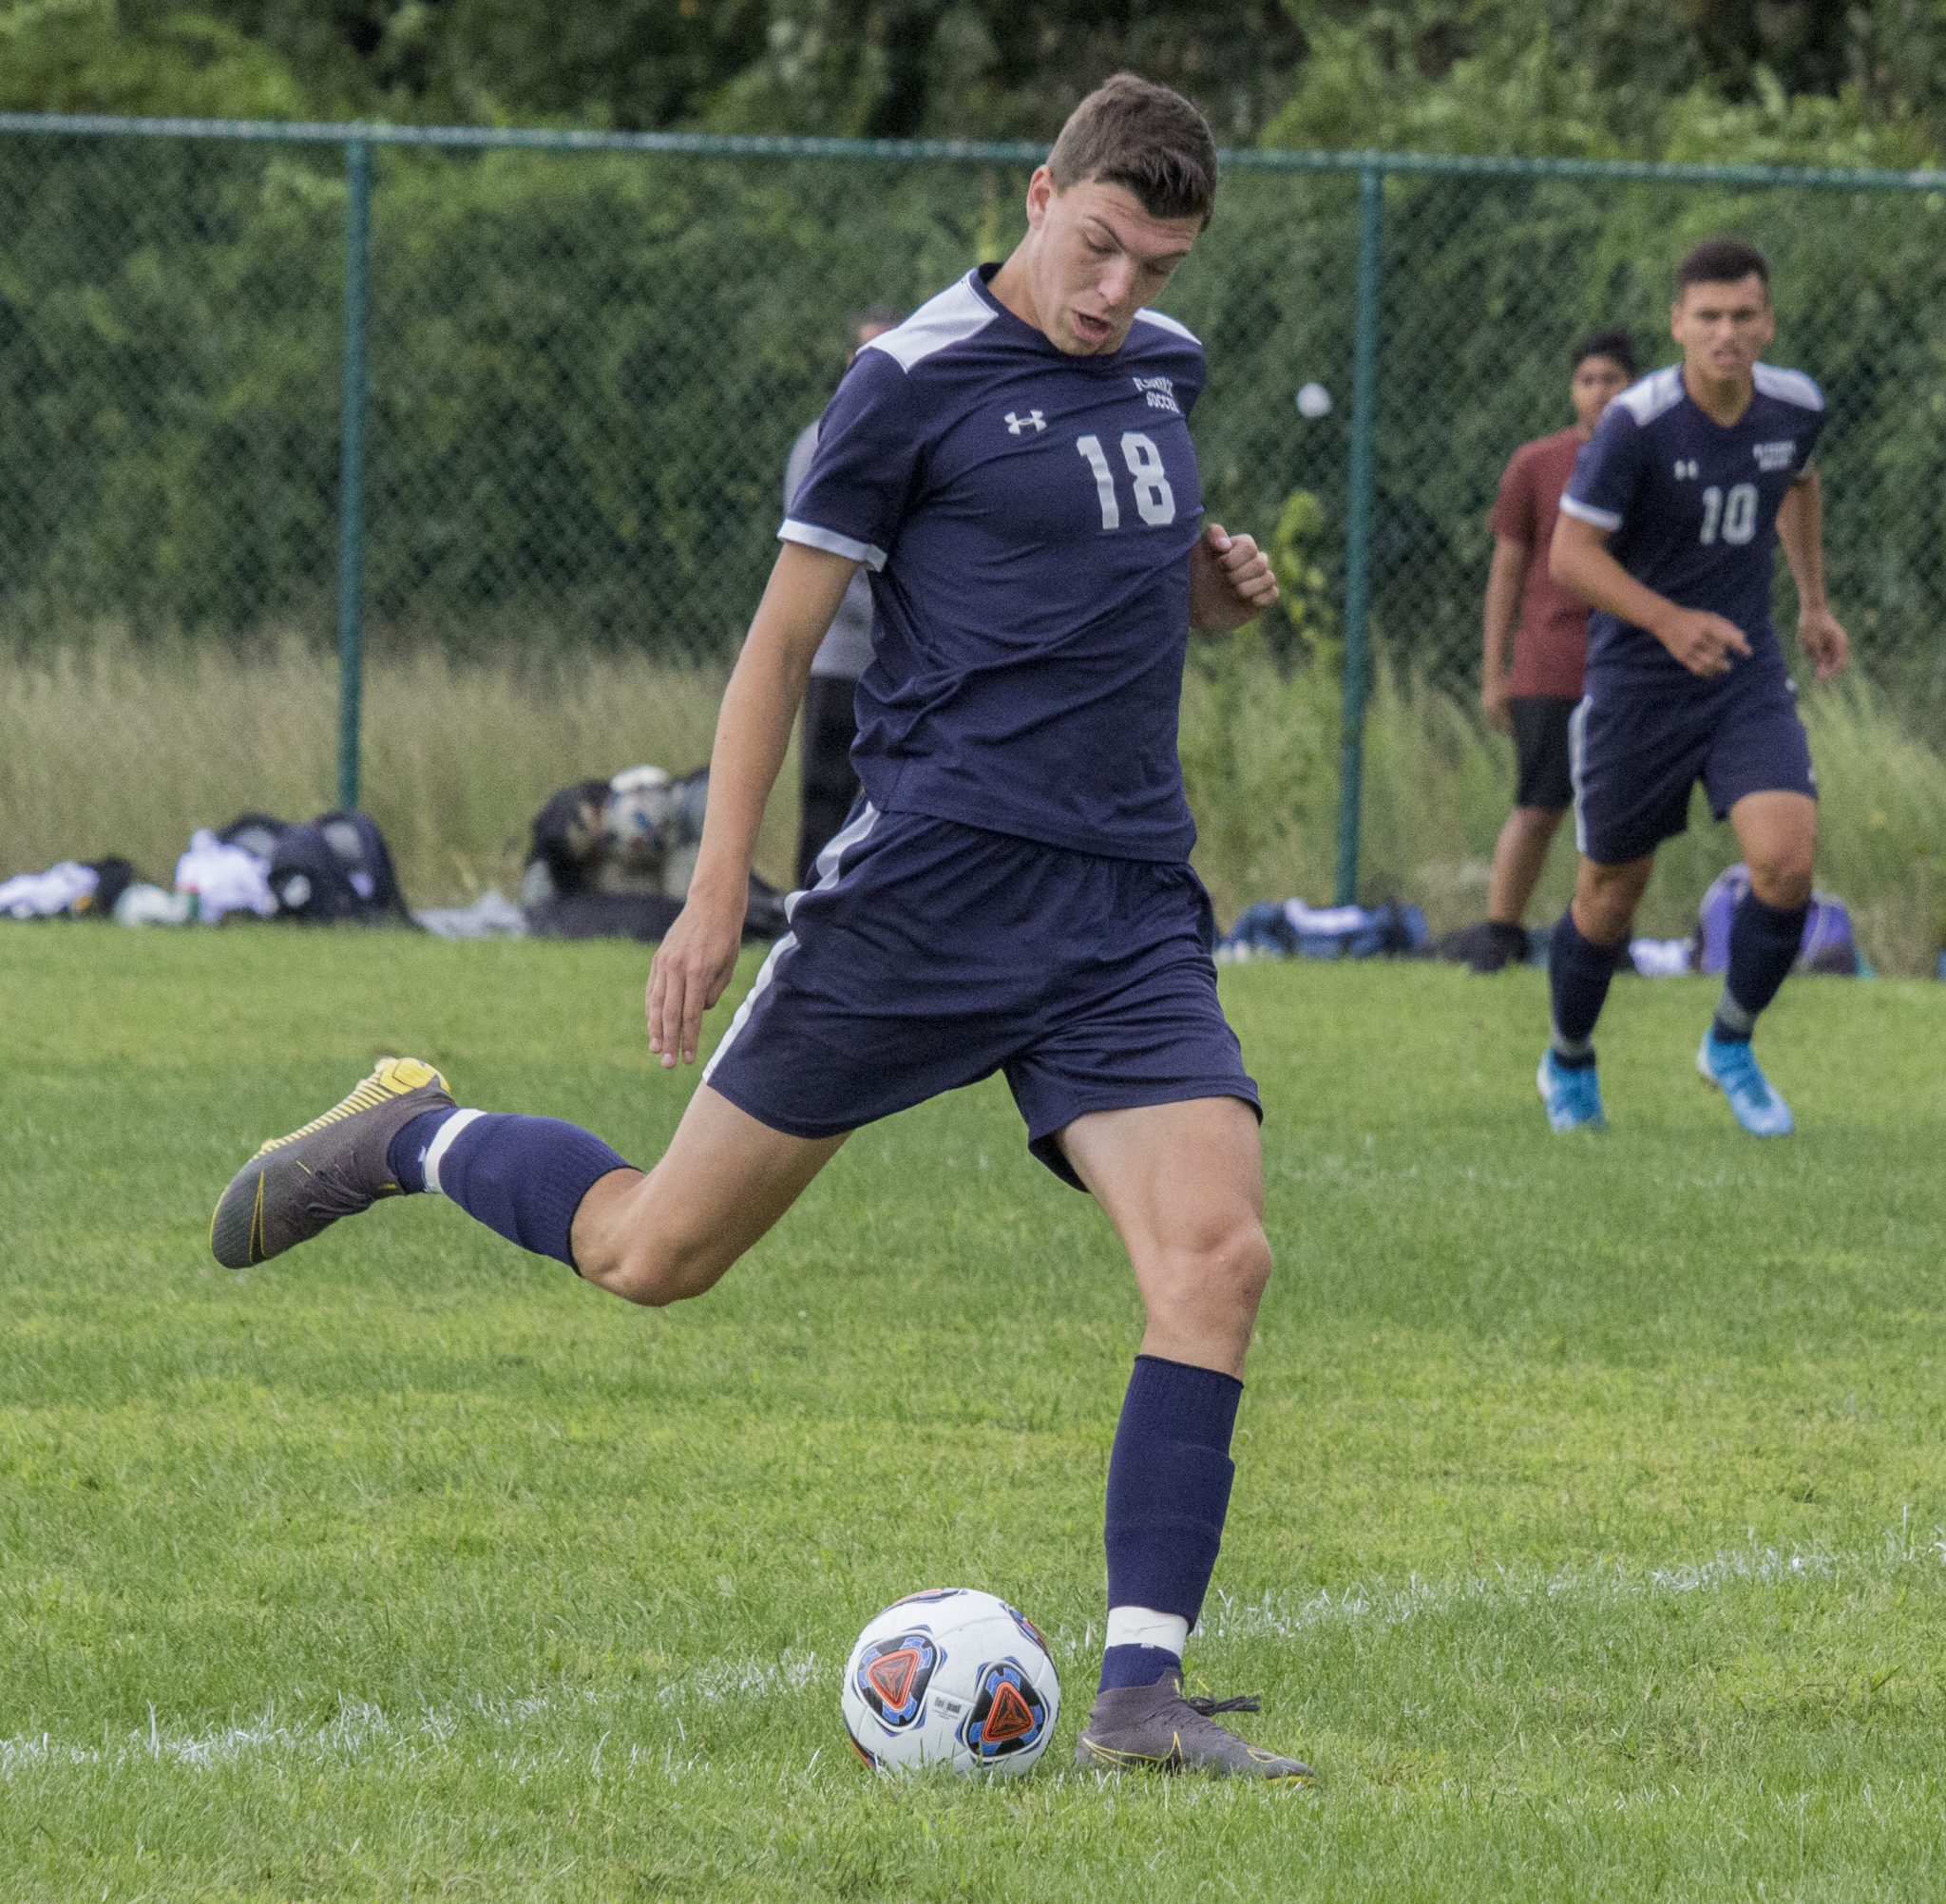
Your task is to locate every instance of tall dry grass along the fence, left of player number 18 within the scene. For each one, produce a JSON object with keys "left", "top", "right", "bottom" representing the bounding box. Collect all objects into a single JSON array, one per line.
[{"left": 0, "top": 638, "right": 796, "bottom": 904}]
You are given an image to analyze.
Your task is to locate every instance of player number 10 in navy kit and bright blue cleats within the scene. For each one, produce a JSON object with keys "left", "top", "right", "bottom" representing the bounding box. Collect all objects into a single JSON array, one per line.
[{"left": 1539, "top": 238, "right": 1849, "bottom": 1137}]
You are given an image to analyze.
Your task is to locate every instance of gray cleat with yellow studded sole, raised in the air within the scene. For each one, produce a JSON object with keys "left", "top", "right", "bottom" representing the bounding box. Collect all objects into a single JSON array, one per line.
[{"left": 210, "top": 1058, "right": 453, "bottom": 1270}]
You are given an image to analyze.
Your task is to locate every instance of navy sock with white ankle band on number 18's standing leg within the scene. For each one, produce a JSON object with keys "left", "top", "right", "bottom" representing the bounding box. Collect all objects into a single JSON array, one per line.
[{"left": 1101, "top": 1356, "right": 1244, "bottom": 1692}]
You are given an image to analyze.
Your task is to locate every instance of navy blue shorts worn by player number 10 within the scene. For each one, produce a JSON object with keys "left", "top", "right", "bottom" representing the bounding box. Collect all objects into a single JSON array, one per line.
[{"left": 1569, "top": 669, "right": 1818, "bottom": 866}]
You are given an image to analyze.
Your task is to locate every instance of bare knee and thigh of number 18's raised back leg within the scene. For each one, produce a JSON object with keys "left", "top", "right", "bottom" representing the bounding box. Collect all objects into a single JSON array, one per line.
[{"left": 572, "top": 1085, "right": 845, "bottom": 1307}]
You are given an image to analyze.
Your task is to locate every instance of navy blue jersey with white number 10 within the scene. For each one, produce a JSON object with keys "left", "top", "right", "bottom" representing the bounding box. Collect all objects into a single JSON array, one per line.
[{"left": 1560, "top": 364, "right": 1823, "bottom": 693}]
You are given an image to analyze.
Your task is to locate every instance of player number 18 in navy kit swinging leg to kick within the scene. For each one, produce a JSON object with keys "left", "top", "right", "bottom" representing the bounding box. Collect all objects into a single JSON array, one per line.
[{"left": 212, "top": 74, "right": 1307, "bottom": 1780}]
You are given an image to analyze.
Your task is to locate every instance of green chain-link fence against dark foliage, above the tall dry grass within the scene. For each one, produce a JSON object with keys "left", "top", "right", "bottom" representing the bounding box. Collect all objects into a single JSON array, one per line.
[{"left": 0, "top": 117, "right": 1946, "bottom": 885}]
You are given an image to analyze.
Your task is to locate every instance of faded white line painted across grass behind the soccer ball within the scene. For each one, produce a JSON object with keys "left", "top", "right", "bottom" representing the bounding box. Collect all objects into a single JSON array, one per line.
[{"left": 0, "top": 1525, "right": 1946, "bottom": 1781}]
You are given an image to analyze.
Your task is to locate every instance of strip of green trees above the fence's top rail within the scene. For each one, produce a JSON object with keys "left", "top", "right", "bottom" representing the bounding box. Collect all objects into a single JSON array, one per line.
[{"left": 11, "top": 0, "right": 1946, "bottom": 162}]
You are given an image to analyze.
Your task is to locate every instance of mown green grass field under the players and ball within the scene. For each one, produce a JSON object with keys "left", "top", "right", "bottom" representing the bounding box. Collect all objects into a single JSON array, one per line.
[{"left": 0, "top": 925, "right": 1946, "bottom": 1904}]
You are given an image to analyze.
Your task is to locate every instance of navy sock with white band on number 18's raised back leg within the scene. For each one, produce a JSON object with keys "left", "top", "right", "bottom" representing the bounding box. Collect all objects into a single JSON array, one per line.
[{"left": 388, "top": 1111, "right": 629, "bottom": 1270}]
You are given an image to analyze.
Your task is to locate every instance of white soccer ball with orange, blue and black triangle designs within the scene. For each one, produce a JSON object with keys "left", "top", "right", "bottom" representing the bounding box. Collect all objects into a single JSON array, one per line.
[{"left": 841, "top": 1587, "right": 1060, "bottom": 1776}]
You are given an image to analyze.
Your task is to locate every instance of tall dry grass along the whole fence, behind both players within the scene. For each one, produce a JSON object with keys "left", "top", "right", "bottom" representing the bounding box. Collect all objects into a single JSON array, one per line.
[{"left": 11, "top": 638, "right": 1946, "bottom": 972}]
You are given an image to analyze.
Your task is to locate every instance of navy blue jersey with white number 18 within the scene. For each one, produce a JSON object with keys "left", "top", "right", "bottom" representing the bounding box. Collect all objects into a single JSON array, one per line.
[{"left": 780, "top": 264, "right": 1203, "bottom": 860}]
